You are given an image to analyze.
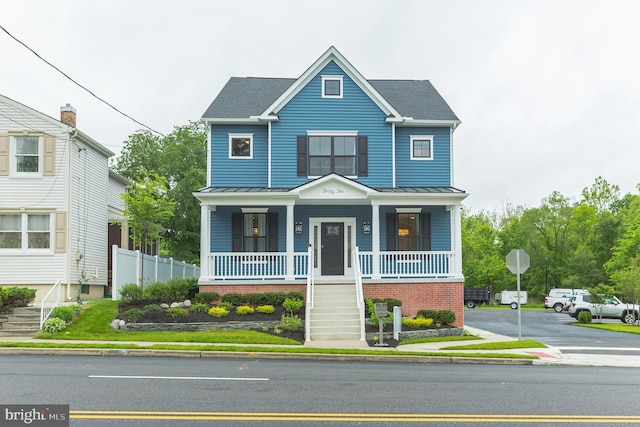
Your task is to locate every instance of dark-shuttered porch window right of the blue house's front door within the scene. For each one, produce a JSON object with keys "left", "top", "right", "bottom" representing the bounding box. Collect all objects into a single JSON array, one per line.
[{"left": 387, "top": 212, "right": 431, "bottom": 251}]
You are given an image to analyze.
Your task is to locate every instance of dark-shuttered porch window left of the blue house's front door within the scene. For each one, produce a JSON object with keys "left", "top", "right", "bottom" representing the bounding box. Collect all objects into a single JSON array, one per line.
[{"left": 231, "top": 212, "right": 278, "bottom": 252}]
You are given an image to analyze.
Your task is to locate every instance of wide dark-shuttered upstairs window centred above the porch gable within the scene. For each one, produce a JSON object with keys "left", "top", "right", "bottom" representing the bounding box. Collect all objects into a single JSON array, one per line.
[{"left": 298, "top": 135, "right": 368, "bottom": 176}]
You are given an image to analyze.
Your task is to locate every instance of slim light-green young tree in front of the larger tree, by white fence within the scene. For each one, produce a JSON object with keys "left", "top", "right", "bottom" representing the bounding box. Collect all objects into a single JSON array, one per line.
[{"left": 120, "top": 170, "right": 173, "bottom": 286}]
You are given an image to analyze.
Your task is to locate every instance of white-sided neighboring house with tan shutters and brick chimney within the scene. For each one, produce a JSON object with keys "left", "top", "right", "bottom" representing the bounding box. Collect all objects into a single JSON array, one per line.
[{"left": 0, "top": 95, "right": 114, "bottom": 301}]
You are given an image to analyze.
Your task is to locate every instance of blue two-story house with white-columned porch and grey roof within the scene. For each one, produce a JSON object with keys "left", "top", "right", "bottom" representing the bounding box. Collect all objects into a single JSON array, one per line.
[{"left": 194, "top": 47, "right": 467, "bottom": 342}]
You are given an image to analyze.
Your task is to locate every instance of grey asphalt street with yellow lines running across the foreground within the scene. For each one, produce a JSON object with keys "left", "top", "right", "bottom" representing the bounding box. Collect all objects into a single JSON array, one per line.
[{"left": 0, "top": 356, "right": 640, "bottom": 427}]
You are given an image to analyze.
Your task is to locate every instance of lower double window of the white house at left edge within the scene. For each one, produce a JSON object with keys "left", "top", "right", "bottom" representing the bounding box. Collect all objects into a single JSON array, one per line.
[{"left": 0, "top": 213, "right": 51, "bottom": 250}]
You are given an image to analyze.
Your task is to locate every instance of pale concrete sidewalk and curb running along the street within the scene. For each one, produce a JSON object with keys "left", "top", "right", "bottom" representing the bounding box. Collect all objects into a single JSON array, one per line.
[{"left": 0, "top": 326, "right": 640, "bottom": 367}]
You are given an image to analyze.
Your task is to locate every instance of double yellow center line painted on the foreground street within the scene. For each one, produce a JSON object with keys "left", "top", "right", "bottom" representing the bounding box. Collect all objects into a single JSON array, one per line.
[{"left": 69, "top": 411, "right": 640, "bottom": 424}]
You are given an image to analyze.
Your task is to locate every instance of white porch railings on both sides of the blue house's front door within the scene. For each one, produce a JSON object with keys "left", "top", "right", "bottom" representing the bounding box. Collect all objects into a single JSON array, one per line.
[{"left": 203, "top": 251, "right": 462, "bottom": 280}]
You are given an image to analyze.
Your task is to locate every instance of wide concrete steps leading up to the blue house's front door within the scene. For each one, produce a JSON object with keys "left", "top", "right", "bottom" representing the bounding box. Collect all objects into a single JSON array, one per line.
[{"left": 309, "top": 284, "right": 360, "bottom": 341}]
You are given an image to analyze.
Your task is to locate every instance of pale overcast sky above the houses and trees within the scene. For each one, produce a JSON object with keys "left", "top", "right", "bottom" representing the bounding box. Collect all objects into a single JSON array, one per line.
[{"left": 0, "top": 0, "right": 640, "bottom": 212}]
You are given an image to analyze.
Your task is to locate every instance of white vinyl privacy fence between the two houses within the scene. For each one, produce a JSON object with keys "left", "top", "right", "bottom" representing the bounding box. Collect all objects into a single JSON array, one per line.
[{"left": 111, "top": 245, "right": 200, "bottom": 300}]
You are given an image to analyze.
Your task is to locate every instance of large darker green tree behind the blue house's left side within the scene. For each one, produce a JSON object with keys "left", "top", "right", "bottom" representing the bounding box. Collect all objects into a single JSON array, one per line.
[{"left": 115, "top": 122, "right": 207, "bottom": 263}]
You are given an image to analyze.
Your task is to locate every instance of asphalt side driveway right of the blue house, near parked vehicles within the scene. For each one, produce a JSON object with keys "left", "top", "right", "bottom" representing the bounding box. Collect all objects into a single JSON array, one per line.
[{"left": 464, "top": 309, "right": 640, "bottom": 357}]
